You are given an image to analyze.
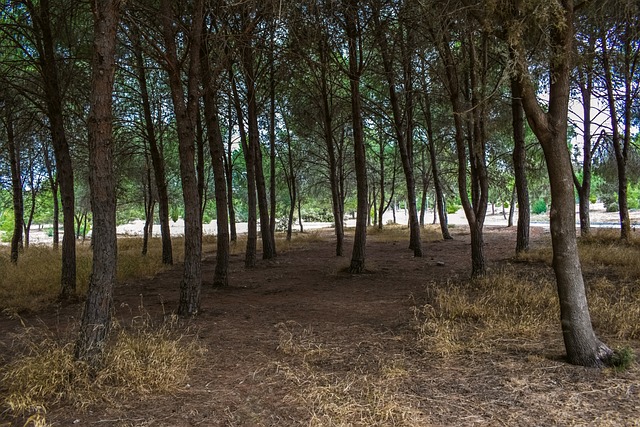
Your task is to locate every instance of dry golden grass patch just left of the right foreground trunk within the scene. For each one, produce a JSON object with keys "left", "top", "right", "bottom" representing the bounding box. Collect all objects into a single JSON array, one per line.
[{"left": 414, "top": 268, "right": 559, "bottom": 357}]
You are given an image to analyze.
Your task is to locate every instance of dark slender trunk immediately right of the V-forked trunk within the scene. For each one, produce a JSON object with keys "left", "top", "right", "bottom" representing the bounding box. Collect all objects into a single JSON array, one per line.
[{"left": 200, "top": 39, "right": 229, "bottom": 286}]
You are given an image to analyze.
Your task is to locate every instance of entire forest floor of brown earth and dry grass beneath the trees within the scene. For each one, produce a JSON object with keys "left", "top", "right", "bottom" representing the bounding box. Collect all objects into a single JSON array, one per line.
[{"left": 0, "top": 227, "right": 640, "bottom": 427}]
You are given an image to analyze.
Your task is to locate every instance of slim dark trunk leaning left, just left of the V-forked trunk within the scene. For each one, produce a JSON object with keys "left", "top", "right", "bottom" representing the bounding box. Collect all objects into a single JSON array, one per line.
[{"left": 132, "top": 29, "right": 173, "bottom": 265}]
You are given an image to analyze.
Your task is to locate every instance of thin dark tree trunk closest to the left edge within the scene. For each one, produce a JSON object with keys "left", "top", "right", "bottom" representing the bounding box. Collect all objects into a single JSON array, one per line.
[{"left": 5, "top": 100, "right": 23, "bottom": 264}]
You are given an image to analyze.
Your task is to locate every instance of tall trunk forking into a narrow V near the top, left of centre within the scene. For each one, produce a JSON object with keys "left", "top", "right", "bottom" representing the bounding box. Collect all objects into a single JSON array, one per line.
[{"left": 161, "top": 0, "right": 204, "bottom": 316}]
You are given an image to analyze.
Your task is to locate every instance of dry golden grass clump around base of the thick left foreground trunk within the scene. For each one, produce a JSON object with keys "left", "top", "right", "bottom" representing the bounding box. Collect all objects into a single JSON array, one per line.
[{"left": 0, "top": 317, "right": 205, "bottom": 425}]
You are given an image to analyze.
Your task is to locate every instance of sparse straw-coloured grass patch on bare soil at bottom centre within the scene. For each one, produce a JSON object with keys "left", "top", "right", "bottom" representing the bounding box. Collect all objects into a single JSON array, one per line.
[{"left": 273, "top": 322, "right": 424, "bottom": 427}]
